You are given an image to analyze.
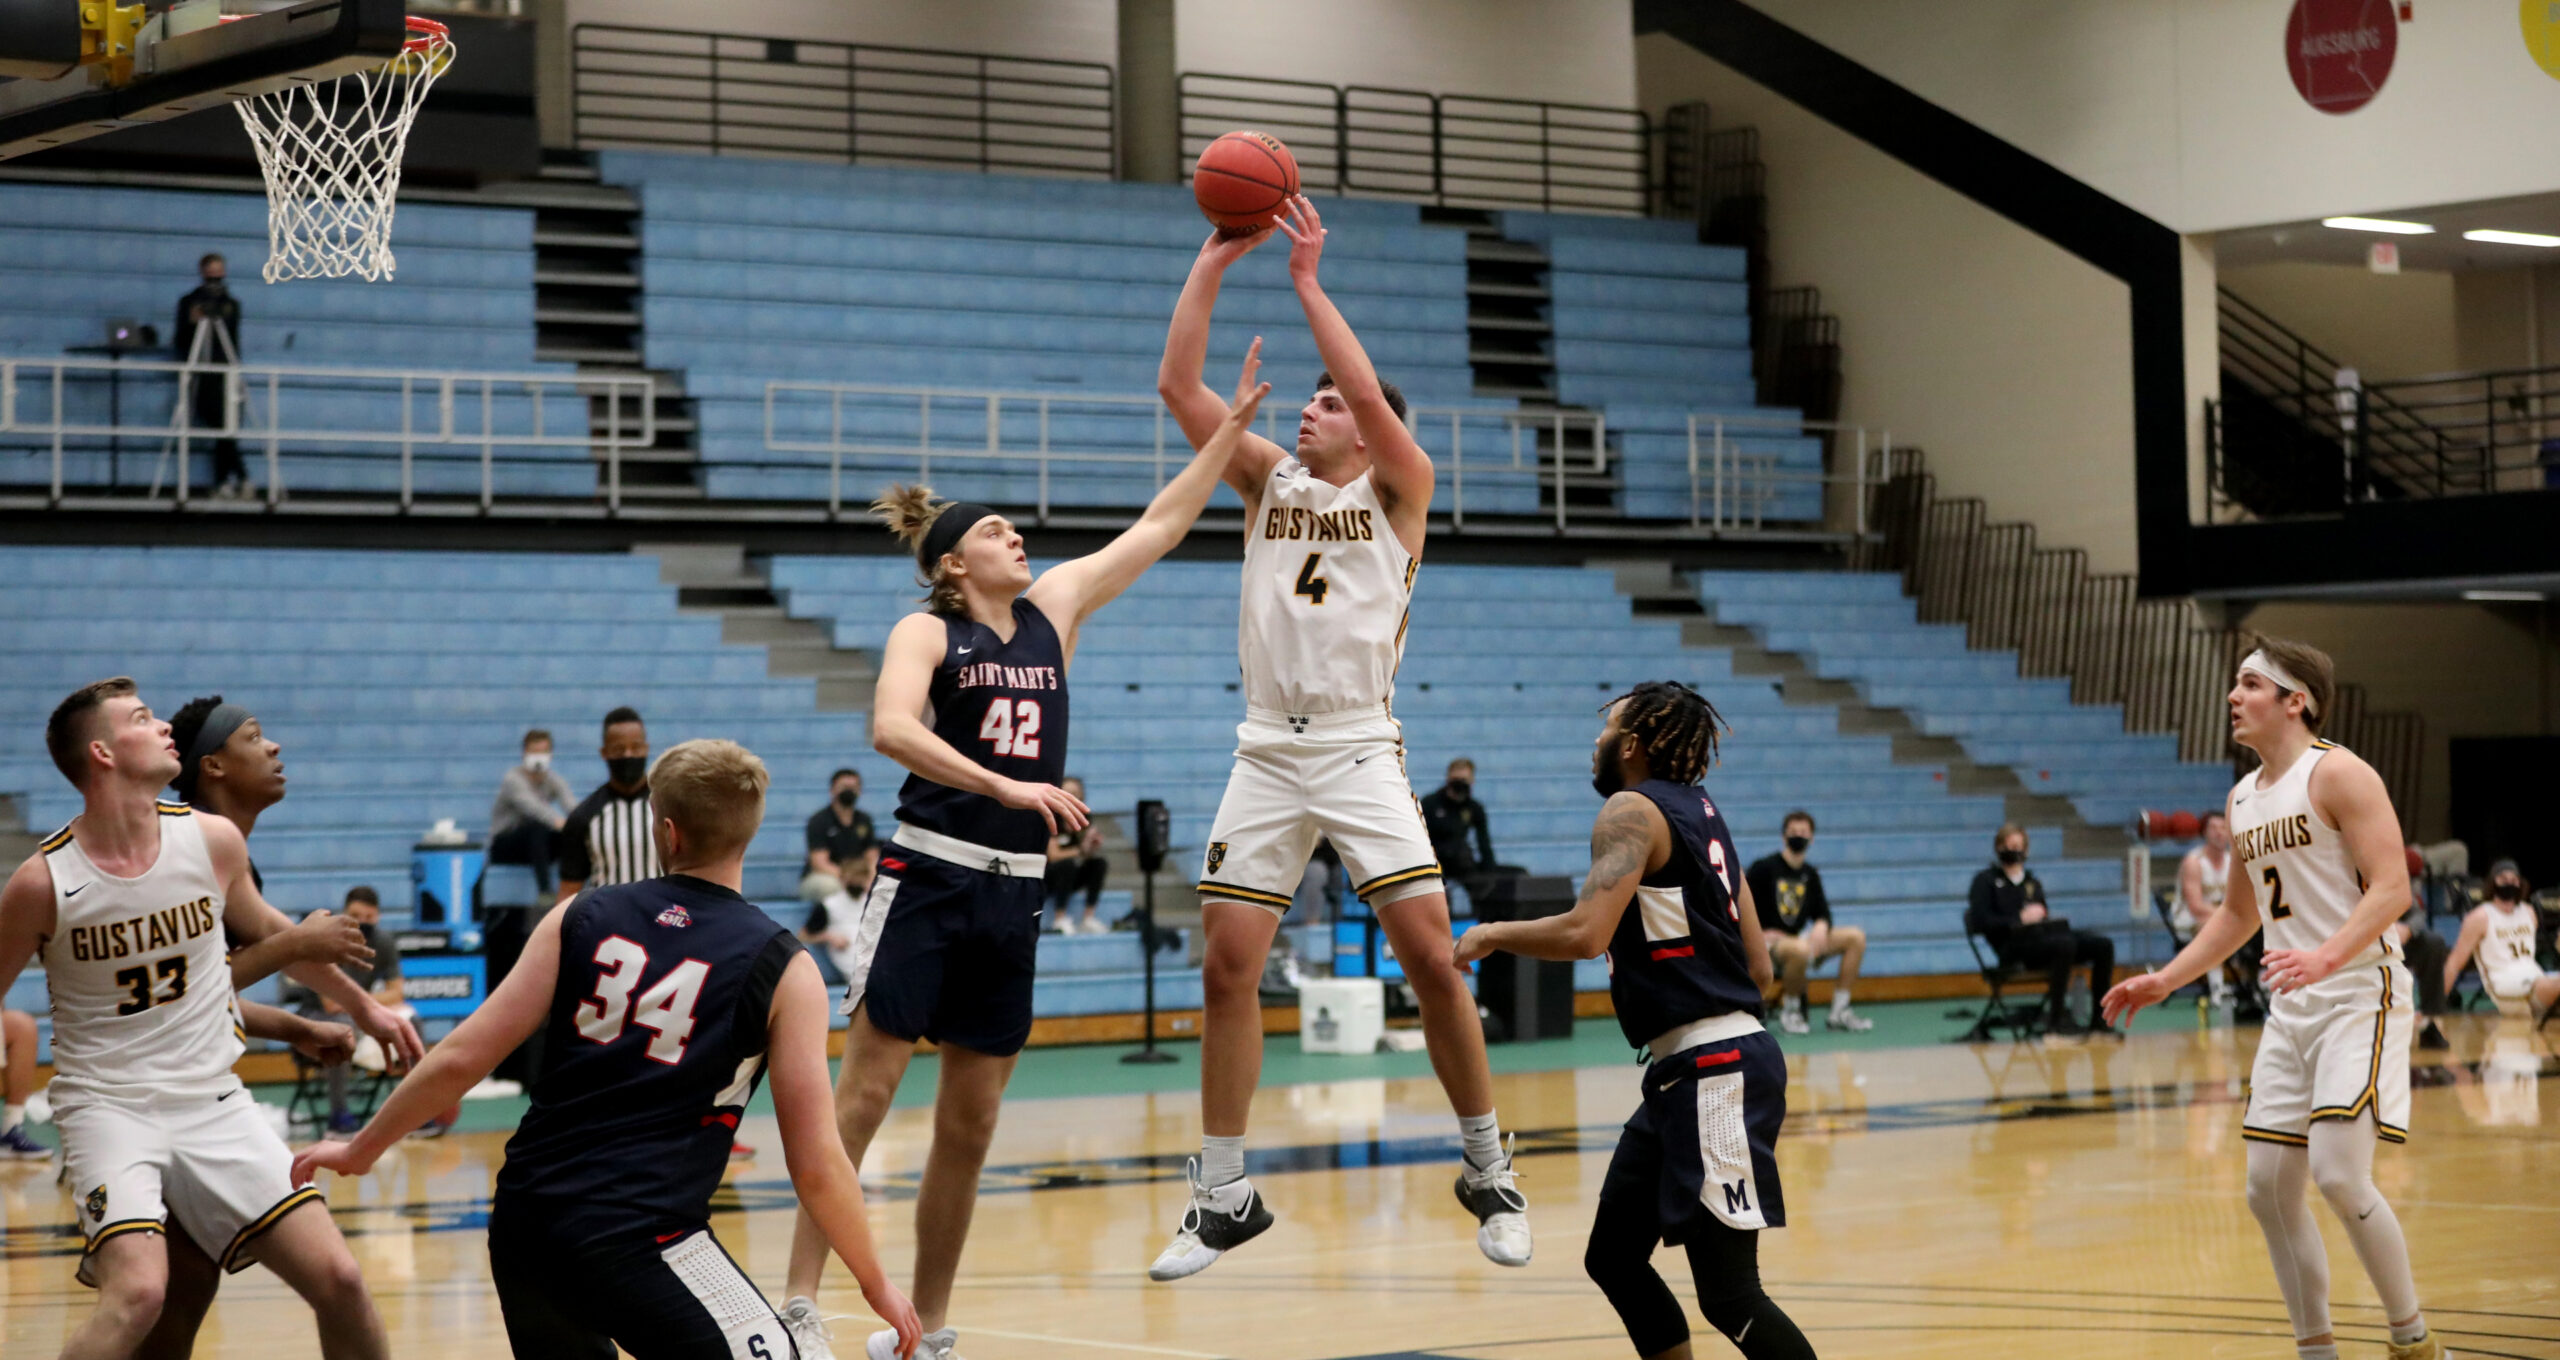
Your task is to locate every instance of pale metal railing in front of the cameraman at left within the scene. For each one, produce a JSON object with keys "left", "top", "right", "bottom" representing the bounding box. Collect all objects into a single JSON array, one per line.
[{"left": 0, "top": 356, "right": 658, "bottom": 510}]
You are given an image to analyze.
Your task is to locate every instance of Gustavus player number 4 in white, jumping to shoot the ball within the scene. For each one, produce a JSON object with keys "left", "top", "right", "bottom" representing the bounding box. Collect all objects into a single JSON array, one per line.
[{"left": 1147, "top": 197, "right": 1531, "bottom": 1281}]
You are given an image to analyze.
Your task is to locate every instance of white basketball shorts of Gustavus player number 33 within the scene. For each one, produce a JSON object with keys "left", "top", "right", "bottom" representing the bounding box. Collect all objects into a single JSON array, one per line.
[{"left": 51, "top": 1081, "right": 320, "bottom": 1286}]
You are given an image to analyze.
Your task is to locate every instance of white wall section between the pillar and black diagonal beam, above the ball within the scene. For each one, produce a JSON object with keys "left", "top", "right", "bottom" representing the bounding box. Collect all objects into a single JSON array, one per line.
[{"left": 1172, "top": 0, "right": 1636, "bottom": 108}]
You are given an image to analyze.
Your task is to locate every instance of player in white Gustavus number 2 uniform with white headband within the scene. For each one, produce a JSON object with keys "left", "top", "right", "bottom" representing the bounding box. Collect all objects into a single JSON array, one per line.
[{"left": 2104, "top": 638, "right": 2445, "bottom": 1360}]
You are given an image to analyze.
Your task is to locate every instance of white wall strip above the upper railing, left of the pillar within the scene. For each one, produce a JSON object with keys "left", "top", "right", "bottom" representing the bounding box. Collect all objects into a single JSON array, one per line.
[{"left": 566, "top": 0, "right": 1119, "bottom": 67}]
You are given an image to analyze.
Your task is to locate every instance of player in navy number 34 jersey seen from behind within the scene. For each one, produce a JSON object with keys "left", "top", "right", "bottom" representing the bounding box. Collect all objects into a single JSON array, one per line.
[{"left": 294, "top": 740, "right": 919, "bottom": 1360}]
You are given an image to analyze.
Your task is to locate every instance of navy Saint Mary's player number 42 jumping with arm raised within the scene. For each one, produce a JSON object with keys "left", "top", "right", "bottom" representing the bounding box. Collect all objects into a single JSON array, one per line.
[{"left": 783, "top": 338, "right": 1270, "bottom": 1360}]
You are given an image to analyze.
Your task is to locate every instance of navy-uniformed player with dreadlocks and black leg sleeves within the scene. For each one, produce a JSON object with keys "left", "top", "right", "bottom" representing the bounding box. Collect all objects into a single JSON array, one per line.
[{"left": 1457, "top": 681, "right": 1812, "bottom": 1360}]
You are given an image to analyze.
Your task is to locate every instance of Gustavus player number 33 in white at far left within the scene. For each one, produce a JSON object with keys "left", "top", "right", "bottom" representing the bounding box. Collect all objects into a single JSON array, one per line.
[{"left": 0, "top": 676, "right": 415, "bottom": 1360}]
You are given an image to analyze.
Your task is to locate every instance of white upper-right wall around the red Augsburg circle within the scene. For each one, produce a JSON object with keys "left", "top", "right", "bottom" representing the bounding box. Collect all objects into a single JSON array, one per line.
[{"left": 1751, "top": 0, "right": 2560, "bottom": 233}]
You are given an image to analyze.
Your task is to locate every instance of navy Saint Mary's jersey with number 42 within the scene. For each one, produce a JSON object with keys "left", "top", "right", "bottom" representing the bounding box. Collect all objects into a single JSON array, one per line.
[{"left": 899, "top": 599, "right": 1068, "bottom": 855}]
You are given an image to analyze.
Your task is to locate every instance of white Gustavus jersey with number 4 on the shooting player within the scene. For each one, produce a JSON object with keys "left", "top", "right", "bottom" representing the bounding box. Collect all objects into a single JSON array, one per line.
[{"left": 1236, "top": 458, "right": 1421, "bottom": 715}]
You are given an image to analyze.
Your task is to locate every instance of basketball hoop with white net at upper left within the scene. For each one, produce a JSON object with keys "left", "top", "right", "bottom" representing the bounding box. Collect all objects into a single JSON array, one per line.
[{"left": 236, "top": 15, "right": 453, "bottom": 284}]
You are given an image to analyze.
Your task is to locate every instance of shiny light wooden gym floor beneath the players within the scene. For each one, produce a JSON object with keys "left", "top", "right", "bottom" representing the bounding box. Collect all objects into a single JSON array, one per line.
[{"left": 0, "top": 1001, "right": 2560, "bottom": 1360}]
